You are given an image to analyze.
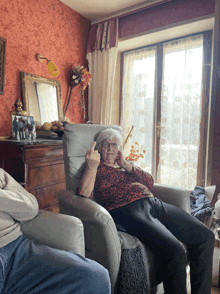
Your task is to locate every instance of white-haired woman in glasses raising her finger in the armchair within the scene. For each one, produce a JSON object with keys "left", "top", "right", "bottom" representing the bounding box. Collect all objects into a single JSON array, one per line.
[{"left": 77, "top": 129, "right": 214, "bottom": 294}]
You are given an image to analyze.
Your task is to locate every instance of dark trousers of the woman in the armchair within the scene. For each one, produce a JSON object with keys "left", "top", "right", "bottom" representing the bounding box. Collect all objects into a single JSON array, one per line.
[{"left": 109, "top": 197, "right": 215, "bottom": 294}]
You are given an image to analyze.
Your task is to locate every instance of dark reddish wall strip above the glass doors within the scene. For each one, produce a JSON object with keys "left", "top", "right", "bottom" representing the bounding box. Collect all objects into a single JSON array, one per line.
[{"left": 119, "top": 0, "right": 215, "bottom": 38}]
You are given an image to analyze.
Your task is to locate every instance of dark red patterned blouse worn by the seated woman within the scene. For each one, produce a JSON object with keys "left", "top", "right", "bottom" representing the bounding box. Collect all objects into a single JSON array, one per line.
[{"left": 93, "top": 161, "right": 154, "bottom": 210}]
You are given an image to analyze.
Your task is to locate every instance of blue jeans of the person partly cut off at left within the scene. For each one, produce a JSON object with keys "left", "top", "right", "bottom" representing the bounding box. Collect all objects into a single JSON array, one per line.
[{"left": 0, "top": 236, "right": 111, "bottom": 294}]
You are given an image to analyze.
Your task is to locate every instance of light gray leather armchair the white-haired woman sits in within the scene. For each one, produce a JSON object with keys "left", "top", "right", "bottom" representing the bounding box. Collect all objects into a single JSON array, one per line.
[{"left": 58, "top": 124, "right": 190, "bottom": 294}]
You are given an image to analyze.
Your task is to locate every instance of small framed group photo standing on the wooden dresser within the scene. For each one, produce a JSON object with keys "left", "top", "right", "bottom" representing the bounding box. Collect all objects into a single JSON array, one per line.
[{"left": 12, "top": 114, "right": 37, "bottom": 141}]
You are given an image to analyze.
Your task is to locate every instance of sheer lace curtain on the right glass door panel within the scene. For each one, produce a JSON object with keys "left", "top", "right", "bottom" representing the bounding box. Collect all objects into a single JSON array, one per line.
[{"left": 157, "top": 34, "right": 203, "bottom": 189}]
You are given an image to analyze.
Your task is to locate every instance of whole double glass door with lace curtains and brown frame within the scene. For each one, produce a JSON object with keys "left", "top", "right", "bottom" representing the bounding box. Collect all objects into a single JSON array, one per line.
[{"left": 122, "top": 34, "right": 211, "bottom": 189}]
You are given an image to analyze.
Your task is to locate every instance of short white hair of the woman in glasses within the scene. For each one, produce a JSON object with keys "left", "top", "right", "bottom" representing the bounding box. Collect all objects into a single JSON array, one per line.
[{"left": 96, "top": 128, "right": 123, "bottom": 152}]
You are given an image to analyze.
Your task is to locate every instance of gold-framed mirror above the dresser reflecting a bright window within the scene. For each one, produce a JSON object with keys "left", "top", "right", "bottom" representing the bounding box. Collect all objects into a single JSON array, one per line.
[{"left": 21, "top": 72, "right": 63, "bottom": 125}]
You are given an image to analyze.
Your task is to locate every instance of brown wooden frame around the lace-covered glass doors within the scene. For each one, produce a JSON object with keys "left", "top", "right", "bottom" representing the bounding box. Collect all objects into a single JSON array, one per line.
[{"left": 120, "top": 30, "right": 213, "bottom": 187}]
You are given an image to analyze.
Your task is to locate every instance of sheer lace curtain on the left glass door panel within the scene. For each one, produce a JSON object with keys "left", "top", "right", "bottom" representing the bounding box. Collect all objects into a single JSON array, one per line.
[{"left": 122, "top": 46, "right": 156, "bottom": 168}]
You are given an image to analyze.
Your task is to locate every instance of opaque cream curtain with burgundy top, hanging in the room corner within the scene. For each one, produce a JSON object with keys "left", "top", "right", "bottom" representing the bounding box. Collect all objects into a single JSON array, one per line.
[{"left": 87, "top": 19, "right": 118, "bottom": 124}]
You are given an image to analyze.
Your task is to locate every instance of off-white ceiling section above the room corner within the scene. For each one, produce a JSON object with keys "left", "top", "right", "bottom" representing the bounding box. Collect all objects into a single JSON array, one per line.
[{"left": 60, "top": 0, "right": 164, "bottom": 23}]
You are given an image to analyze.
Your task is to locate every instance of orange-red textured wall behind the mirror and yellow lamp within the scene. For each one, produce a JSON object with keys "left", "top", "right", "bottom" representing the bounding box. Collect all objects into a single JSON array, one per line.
[{"left": 0, "top": 0, "right": 90, "bottom": 136}]
